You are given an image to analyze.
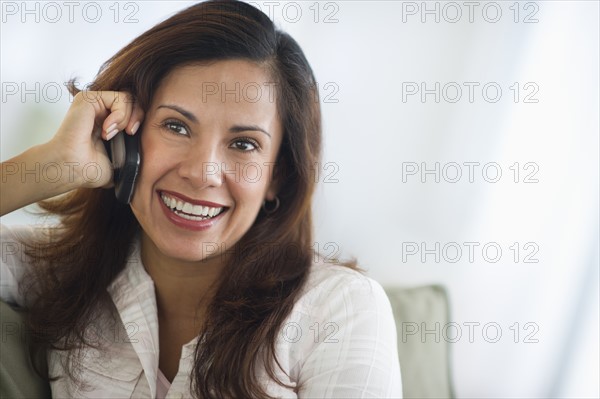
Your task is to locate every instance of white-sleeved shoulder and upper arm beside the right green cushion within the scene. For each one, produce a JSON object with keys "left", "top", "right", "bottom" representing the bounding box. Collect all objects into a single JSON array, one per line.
[{"left": 278, "top": 262, "right": 402, "bottom": 398}]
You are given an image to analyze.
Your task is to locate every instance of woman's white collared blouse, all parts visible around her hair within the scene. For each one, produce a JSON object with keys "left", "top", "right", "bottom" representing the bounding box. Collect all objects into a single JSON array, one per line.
[{"left": 0, "top": 225, "right": 402, "bottom": 398}]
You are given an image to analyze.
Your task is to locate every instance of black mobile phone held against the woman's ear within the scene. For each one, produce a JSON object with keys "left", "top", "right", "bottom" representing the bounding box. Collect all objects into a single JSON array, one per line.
[{"left": 104, "top": 131, "right": 141, "bottom": 204}]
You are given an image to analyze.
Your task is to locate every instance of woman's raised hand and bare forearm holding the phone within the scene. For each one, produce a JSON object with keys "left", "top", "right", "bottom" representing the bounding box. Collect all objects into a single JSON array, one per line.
[{"left": 0, "top": 91, "right": 144, "bottom": 215}]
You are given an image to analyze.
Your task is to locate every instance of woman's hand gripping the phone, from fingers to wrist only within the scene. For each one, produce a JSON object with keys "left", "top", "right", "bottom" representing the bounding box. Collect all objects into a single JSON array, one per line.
[{"left": 46, "top": 91, "right": 144, "bottom": 188}]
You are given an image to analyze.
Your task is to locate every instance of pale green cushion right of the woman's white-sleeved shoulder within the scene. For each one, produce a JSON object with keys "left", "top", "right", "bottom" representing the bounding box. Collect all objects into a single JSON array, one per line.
[{"left": 384, "top": 285, "right": 454, "bottom": 398}]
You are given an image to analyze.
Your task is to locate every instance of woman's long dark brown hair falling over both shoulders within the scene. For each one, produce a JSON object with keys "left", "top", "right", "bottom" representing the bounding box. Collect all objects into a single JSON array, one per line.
[{"left": 19, "top": 1, "right": 353, "bottom": 398}]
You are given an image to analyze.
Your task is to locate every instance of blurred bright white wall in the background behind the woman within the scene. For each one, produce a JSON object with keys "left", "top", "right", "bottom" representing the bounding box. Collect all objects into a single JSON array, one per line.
[{"left": 1, "top": 1, "right": 600, "bottom": 398}]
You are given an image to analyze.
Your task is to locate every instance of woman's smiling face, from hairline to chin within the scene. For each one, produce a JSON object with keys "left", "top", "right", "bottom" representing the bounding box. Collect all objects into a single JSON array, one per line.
[{"left": 131, "top": 60, "right": 282, "bottom": 261}]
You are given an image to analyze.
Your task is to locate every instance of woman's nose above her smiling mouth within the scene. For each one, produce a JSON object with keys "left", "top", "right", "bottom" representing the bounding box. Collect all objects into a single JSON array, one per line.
[{"left": 178, "top": 142, "right": 223, "bottom": 189}]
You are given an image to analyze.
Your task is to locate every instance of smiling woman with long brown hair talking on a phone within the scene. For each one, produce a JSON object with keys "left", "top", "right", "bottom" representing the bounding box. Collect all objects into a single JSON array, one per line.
[{"left": 1, "top": 1, "right": 401, "bottom": 398}]
